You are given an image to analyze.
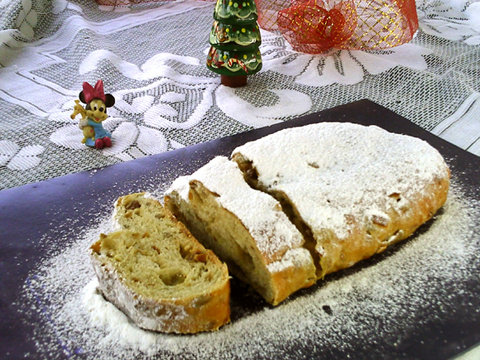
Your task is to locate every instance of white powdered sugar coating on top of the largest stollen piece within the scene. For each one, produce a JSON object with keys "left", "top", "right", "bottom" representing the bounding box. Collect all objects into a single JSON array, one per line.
[{"left": 233, "top": 123, "right": 448, "bottom": 239}]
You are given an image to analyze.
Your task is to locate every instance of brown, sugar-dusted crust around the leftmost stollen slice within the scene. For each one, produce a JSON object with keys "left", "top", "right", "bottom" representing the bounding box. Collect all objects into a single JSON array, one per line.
[{"left": 90, "top": 193, "right": 230, "bottom": 334}]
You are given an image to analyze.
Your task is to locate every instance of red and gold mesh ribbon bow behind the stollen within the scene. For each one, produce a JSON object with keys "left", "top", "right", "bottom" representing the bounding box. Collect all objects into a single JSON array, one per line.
[{"left": 257, "top": 0, "right": 418, "bottom": 54}]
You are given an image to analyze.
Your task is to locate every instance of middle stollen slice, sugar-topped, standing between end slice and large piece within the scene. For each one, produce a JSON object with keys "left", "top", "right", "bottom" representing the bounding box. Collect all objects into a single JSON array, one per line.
[{"left": 165, "top": 156, "right": 316, "bottom": 305}]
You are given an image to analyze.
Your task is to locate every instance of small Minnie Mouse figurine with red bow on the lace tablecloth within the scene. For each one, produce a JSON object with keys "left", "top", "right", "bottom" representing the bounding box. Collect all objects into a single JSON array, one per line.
[{"left": 70, "top": 80, "right": 115, "bottom": 149}]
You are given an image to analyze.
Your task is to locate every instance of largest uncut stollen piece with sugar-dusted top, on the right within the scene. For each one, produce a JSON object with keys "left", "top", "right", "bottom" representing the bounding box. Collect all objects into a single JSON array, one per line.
[{"left": 232, "top": 123, "right": 450, "bottom": 278}]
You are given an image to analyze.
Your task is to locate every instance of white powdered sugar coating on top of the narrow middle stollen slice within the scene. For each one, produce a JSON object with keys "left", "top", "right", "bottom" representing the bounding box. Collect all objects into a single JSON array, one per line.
[{"left": 167, "top": 156, "right": 312, "bottom": 264}]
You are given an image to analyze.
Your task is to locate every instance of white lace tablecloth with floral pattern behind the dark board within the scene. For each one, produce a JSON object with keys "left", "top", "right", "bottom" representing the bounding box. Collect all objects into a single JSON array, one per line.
[{"left": 0, "top": 0, "right": 480, "bottom": 189}]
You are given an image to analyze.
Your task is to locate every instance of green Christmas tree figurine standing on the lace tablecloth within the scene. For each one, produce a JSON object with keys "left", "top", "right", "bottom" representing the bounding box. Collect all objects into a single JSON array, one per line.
[{"left": 207, "top": 0, "right": 262, "bottom": 87}]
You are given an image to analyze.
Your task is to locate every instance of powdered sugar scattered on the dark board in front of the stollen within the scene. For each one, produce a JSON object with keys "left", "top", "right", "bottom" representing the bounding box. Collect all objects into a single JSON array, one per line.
[{"left": 22, "top": 179, "right": 480, "bottom": 359}]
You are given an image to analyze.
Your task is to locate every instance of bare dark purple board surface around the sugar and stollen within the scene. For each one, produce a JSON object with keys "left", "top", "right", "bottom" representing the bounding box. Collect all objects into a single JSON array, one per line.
[{"left": 0, "top": 100, "right": 480, "bottom": 359}]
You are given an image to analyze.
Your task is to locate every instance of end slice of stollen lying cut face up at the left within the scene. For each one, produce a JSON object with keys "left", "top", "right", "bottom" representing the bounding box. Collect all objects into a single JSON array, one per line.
[{"left": 91, "top": 194, "right": 230, "bottom": 333}]
